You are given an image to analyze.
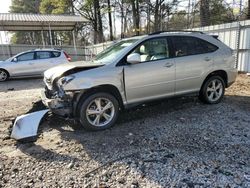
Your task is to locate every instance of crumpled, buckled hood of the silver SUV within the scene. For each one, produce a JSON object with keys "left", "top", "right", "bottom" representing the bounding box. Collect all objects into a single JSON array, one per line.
[{"left": 44, "top": 61, "right": 103, "bottom": 83}]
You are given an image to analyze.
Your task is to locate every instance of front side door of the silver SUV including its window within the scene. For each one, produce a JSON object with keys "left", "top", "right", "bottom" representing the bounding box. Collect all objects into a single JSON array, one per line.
[{"left": 124, "top": 37, "right": 175, "bottom": 103}]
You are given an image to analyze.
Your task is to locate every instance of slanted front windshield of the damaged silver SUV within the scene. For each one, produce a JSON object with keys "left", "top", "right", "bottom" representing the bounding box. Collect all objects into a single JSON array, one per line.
[{"left": 95, "top": 39, "right": 138, "bottom": 63}]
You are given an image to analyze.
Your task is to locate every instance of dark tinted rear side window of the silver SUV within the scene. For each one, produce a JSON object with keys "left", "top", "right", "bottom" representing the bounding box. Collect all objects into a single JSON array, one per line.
[{"left": 172, "top": 36, "right": 218, "bottom": 57}]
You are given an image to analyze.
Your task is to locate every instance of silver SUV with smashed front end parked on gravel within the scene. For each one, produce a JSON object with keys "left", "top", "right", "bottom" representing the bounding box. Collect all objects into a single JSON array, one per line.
[{"left": 42, "top": 32, "right": 237, "bottom": 130}]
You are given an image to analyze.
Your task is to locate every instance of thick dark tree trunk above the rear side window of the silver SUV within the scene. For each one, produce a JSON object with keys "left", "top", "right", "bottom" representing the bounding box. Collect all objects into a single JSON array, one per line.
[{"left": 200, "top": 0, "right": 210, "bottom": 26}]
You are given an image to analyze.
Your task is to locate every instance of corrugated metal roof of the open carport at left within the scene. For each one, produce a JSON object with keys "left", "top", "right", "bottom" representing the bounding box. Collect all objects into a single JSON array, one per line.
[{"left": 0, "top": 13, "right": 88, "bottom": 31}]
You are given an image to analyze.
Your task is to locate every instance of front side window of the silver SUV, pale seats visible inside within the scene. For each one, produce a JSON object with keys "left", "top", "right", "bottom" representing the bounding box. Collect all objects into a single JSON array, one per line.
[{"left": 132, "top": 38, "right": 169, "bottom": 62}]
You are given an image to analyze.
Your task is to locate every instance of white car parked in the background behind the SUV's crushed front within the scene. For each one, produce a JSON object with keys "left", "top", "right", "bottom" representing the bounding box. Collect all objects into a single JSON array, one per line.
[{"left": 0, "top": 49, "right": 71, "bottom": 81}]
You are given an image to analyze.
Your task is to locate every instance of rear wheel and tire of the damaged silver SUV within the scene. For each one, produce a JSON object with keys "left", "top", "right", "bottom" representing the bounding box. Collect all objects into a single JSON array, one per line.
[{"left": 199, "top": 76, "right": 225, "bottom": 104}]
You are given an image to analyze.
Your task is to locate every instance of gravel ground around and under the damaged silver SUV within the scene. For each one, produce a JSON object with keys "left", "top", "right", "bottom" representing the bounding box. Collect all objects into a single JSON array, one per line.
[{"left": 0, "top": 75, "right": 250, "bottom": 188}]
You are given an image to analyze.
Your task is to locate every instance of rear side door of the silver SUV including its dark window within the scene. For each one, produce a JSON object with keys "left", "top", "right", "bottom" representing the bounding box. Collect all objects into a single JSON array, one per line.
[{"left": 170, "top": 36, "right": 218, "bottom": 95}]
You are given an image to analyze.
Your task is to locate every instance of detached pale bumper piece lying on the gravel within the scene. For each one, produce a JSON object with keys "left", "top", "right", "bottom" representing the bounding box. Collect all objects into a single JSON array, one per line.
[{"left": 11, "top": 109, "right": 49, "bottom": 140}]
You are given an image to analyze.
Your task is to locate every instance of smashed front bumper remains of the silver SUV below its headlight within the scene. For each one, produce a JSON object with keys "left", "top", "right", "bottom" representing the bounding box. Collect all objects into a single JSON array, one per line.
[{"left": 41, "top": 88, "right": 73, "bottom": 117}]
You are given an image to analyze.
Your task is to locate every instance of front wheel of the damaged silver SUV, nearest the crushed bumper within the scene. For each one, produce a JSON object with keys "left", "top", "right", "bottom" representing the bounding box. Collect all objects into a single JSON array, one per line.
[{"left": 78, "top": 93, "right": 119, "bottom": 131}]
